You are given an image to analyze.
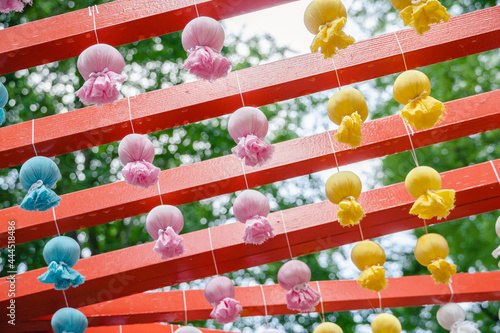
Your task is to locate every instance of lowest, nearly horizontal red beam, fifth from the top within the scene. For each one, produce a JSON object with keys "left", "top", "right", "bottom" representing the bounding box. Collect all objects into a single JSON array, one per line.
[{"left": 19, "top": 272, "right": 500, "bottom": 329}]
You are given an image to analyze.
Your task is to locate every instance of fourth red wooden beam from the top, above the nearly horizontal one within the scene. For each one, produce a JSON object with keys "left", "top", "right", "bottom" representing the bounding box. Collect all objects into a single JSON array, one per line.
[{"left": 0, "top": 160, "right": 500, "bottom": 322}]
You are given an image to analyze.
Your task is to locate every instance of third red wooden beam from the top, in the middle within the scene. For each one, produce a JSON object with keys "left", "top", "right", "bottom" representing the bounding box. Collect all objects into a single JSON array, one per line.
[{"left": 0, "top": 90, "right": 500, "bottom": 247}]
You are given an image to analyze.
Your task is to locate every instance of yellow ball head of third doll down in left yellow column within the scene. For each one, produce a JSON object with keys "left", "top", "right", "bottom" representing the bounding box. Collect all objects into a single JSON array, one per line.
[{"left": 326, "top": 171, "right": 362, "bottom": 205}]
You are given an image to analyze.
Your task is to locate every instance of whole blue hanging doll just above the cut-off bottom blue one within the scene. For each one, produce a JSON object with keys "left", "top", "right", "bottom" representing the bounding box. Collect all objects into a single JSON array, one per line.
[{"left": 38, "top": 236, "right": 85, "bottom": 290}]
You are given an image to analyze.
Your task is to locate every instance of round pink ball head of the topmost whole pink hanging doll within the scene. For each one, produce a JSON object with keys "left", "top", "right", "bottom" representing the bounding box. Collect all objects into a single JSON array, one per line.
[{"left": 182, "top": 16, "right": 225, "bottom": 52}]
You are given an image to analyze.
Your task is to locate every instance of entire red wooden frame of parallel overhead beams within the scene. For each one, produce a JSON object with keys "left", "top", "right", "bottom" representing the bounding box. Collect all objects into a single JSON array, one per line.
[{"left": 0, "top": 0, "right": 500, "bottom": 333}]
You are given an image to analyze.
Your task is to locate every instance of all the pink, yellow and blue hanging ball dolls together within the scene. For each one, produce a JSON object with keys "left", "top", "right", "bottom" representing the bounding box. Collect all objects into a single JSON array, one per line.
[{"left": 0, "top": 0, "right": 488, "bottom": 333}]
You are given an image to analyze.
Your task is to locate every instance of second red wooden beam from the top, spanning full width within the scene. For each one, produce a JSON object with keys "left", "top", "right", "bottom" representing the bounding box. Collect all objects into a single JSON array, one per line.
[{"left": 0, "top": 6, "right": 500, "bottom": 168}]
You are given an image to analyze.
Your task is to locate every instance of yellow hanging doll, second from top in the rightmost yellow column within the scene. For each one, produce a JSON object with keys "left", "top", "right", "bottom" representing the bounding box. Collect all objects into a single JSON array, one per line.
[{"left": 393, "top": 70, "right": 445, "bottom": 130}]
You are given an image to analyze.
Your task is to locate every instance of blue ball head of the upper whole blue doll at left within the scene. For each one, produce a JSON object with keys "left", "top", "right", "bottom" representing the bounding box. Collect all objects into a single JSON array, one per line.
[{"left": 19, "top": 156, "right": 61, "bottom": 191}]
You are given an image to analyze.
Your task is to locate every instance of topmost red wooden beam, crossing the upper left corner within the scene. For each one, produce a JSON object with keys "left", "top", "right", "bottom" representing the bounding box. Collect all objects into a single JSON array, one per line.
[{"left": 0, "top": 0, "right": 297, "bottom": 75}]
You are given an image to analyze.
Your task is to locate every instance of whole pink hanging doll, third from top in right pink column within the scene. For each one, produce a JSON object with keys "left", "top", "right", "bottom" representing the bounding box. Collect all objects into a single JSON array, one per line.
[{"left": 233, "top": 190, "right": 274, "bottom": 245}]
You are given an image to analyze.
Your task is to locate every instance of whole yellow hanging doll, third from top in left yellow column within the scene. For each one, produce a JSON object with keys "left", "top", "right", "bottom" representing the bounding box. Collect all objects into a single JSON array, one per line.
[{"left": 326, "top": 171, "right": 365, "bottom": 226}]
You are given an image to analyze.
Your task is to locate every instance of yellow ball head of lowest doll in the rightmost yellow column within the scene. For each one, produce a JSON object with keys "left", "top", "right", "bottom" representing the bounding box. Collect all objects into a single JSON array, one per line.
[{"left": 414, "top": 233, "right": 450, "bottom": 266}]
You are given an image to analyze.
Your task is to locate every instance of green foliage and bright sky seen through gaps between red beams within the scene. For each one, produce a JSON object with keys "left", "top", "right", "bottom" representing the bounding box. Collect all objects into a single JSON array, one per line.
[{"left": 0, "top": 0, "right": 500, "bottom": 333}]
